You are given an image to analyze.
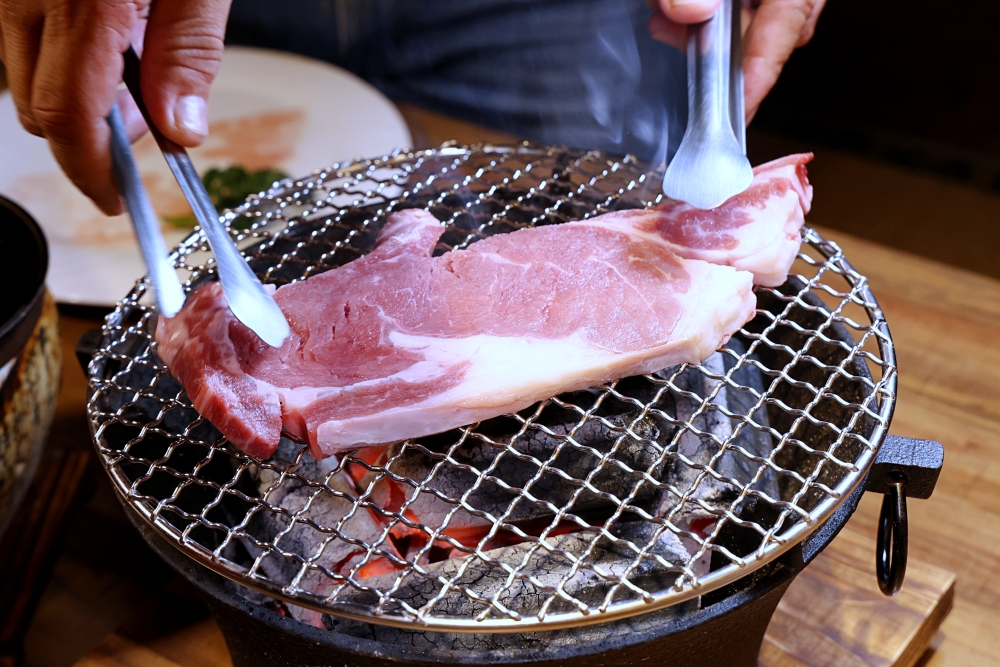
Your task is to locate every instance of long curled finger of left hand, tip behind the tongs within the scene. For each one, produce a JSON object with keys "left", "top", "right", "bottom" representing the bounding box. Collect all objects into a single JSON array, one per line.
[{"left": 31, "top": 0, "right": 135, "bottom": 214}]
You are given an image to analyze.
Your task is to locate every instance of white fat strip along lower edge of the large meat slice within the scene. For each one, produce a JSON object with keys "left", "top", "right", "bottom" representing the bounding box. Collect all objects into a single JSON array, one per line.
[{"left": 302, "top": 260, "right": 756, "bottom": 455}]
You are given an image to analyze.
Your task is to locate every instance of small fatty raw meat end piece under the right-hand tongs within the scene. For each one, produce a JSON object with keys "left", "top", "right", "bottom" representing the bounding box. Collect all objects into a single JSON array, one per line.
[{"left": 590, "top": 153, "right": 813, "bottom": 287}]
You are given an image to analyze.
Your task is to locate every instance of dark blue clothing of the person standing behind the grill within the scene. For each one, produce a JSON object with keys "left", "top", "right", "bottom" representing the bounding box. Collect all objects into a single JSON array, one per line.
[{"left": 229, "top": 0, "right": 687, "bottom": 163}]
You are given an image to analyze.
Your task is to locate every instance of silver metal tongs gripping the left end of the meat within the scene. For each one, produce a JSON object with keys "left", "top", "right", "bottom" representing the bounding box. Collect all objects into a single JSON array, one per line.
[{"left": 108, "top": 47, "right": 290, "bottom": 347}]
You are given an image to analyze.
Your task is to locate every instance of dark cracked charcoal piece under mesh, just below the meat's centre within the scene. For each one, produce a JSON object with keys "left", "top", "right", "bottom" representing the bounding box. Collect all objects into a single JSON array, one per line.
[{"left": 361, "top": 412, "right": 669, "bottom": 530}]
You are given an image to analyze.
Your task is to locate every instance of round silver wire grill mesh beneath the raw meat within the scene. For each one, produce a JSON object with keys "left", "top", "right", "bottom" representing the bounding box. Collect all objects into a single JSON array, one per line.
[{"left": 88, "top": 143, "right": 896, "bottom": 632}]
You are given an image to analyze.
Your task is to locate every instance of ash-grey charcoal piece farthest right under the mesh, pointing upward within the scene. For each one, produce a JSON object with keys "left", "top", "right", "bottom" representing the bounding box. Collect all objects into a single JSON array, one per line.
[{"left": 659, "top": 338, "right": 779, "bottom": 530}]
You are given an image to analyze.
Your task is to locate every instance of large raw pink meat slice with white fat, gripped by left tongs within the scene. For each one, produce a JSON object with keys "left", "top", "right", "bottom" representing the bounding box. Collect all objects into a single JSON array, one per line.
[{"left": 156, "top": 210, "right": 756, "bottom": 458}]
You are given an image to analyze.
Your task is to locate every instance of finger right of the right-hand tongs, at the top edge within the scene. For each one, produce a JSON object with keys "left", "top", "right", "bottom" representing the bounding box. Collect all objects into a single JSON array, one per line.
[{"left": 743, "top": 0, "right": 815, "bottom": 122}]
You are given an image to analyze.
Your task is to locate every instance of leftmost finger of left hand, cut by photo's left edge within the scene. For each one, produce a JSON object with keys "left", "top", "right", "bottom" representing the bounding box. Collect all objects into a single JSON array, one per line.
[{"left": 0, "top": 7, "right": 42, "bottom": 136}]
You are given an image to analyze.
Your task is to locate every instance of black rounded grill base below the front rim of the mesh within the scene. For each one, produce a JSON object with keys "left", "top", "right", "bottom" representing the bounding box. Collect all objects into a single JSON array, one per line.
[{"left": 126, "top": 500, "right": 828, "bottom": 667}]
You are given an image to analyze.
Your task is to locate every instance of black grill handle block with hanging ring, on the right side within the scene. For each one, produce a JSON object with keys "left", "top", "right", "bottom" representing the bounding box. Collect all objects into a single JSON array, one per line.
[{"left": 865, "top": 435, "right": 944, "bottom": 595}]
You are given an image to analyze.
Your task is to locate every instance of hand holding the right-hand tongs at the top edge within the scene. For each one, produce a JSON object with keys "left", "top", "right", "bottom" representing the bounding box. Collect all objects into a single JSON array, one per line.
[{"left": 649, "top": 0, "right": 826, "bottom": 123}]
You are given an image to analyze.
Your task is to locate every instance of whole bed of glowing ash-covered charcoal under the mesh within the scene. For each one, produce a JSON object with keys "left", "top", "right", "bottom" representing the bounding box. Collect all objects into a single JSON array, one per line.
[{"left": 230, "top": 340, "right": 778, "bottom": 650}]
